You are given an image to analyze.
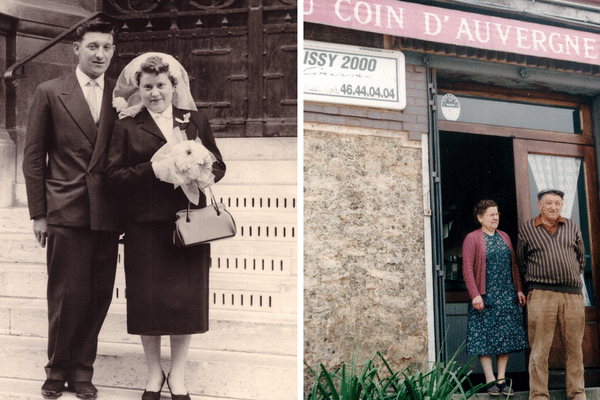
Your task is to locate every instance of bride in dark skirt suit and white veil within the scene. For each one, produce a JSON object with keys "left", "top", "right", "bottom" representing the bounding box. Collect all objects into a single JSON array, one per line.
[{"left": 107, "top": 53, "right": 225, "bottom": 400}]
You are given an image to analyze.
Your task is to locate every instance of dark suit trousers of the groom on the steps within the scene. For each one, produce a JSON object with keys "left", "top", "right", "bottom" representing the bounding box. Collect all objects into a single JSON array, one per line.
[{"left": 46, "top": 225, "right": 119, "bottom": 382}]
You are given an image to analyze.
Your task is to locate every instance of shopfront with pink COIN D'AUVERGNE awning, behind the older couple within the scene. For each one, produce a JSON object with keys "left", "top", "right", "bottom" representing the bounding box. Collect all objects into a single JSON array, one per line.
[{"left": 308, "top": 0, "right": 600, "bottom": 397}]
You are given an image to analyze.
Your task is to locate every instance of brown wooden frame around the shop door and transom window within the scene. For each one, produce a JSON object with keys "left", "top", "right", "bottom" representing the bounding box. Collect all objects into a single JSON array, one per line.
[{"left": 438, "top": 83, "right": 600, "bottom": 385}]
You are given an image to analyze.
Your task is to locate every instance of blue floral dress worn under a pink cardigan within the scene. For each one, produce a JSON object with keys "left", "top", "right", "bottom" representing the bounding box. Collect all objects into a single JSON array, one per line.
[{"left": 467, "top": 232, "right": 527, "bottom": 355}]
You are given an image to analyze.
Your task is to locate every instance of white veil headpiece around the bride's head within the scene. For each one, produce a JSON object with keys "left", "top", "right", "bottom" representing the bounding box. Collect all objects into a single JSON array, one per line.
[{"left": 113, "top": 53, "right": 198, "bottom": 118}]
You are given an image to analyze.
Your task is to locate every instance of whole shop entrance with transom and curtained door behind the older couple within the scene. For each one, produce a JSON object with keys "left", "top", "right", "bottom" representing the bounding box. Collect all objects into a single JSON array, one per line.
[{"left": 438, "top": 88, "right": 600, "bottom": 390}]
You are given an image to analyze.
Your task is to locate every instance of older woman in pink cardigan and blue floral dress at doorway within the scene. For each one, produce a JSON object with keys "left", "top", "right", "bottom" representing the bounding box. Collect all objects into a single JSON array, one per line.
[{"left": 463, "top": 200, "right": 527, "bottom": 396}]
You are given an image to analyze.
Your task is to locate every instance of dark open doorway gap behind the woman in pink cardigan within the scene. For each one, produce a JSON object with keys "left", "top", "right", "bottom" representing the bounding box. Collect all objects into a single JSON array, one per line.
[{"left": 439, "top": 131, "right": 528, "bottom": 390}]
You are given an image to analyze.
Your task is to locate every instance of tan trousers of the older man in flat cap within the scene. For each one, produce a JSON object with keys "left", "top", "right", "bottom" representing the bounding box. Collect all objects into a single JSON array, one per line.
[{"left": 527, "top": 289, "right": 586, "bottom": 400}]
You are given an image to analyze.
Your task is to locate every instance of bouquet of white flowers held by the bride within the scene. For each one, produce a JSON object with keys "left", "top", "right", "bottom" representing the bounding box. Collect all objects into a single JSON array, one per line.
[{"left": 150, "top": 127, "right": 217, "bottom": 205}]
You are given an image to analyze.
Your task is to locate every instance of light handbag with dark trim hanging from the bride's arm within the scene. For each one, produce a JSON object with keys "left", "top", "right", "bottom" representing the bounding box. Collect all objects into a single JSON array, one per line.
[{"left": 173, "top": 187, "right": 236, "bottom": 247}]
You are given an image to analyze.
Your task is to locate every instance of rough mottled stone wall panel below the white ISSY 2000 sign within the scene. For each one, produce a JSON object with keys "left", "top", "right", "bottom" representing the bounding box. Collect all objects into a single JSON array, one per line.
[{"left": 304, "top": 123, "right": 427, "bottom": 389}]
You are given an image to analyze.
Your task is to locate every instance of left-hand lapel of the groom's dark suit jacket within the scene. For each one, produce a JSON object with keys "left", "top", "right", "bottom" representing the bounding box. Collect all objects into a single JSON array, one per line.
[{"left": 59, "top": 72, "right": 98, "bottom": 145}]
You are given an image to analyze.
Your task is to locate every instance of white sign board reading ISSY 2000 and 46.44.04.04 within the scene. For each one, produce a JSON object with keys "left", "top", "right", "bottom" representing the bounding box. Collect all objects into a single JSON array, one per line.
[{"left": 303, "top": 40, "right": 406, "bottom": 110}]
